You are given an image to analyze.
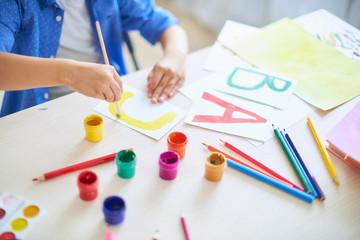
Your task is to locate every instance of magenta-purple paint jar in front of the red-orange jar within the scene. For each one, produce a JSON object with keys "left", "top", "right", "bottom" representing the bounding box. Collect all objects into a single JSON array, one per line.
[{"left": 159, "top": 151, "right": 180, "bottom": 180}]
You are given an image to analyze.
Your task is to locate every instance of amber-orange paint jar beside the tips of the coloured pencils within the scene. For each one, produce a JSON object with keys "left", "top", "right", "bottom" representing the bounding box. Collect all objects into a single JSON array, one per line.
[{"left": 205, "top": 152, "right": 226, "bottom": 181}]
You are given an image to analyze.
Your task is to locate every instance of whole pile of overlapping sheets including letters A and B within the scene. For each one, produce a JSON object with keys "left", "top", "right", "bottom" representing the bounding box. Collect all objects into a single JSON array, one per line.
[{"left": 180, "top": 10, "right": 360, "bottom": 145}]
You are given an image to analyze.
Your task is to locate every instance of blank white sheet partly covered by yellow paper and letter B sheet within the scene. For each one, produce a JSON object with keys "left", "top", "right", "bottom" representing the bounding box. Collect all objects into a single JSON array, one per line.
[{"left": 203, "top": 20, "right": 258, "bottom": 73}]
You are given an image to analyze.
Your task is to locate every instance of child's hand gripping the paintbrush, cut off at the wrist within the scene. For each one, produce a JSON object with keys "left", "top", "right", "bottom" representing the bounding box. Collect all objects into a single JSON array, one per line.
[{"left": 67, "top": 62, "right": 123, "bottom": 102}]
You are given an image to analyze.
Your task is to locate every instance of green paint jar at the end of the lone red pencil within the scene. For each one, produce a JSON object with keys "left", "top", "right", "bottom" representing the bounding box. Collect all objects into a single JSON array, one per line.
[{"left": 115, "top": 149, "right": 136, "bottom": 178}]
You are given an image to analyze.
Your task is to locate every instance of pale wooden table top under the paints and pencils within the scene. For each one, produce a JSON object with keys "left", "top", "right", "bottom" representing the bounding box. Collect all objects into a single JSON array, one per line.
[{"left": 0, "top": 48, "right": 360, "bottom": 240}]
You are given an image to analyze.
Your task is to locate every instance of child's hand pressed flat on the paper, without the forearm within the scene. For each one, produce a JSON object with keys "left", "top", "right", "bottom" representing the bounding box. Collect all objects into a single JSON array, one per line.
[{"left": 147, "top": 54, "right": 185, "bottom": 103}]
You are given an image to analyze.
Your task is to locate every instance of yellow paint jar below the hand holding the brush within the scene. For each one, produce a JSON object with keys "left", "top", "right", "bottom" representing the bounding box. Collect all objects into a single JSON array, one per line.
[{"left": 84, "top": 114, "right": 104, "bottom": 142}]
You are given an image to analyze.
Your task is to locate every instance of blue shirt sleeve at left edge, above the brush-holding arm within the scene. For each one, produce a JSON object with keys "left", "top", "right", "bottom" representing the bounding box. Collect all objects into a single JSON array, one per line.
[{"left": 0, "top": 0, "right": 20, "bottom": 52}]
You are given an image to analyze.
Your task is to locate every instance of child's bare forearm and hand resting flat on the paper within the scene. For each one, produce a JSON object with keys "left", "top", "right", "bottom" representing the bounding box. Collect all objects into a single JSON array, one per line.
[{"left": 147, "top": 25, "right": 188, "bottom": 103}]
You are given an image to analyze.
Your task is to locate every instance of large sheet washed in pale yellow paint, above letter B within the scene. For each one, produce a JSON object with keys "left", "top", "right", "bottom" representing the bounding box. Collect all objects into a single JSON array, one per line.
[{"left": 229, "top": 18, "right": 360, "bottom": 110}]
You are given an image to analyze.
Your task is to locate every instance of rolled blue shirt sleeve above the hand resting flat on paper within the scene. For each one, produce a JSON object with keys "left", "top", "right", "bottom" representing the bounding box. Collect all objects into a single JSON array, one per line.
[{"left": 120, "top": 0, "right": 178, "bottom": 45}]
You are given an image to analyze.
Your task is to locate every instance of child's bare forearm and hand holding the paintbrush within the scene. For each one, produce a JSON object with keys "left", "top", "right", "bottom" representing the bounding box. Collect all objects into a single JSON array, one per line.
[{"left": 0, "top": 52, "right": 122, "bottom": 102}]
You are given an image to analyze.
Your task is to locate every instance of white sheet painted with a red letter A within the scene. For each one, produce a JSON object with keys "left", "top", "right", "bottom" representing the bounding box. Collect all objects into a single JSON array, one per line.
[{"left": 185, "top": 90, "right": 273, "bottom": 141}]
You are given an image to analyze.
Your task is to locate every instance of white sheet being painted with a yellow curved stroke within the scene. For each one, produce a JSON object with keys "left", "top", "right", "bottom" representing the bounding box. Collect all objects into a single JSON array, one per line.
[{"left": 94, "top": 84, "right": 185, "bottom": 140}]
